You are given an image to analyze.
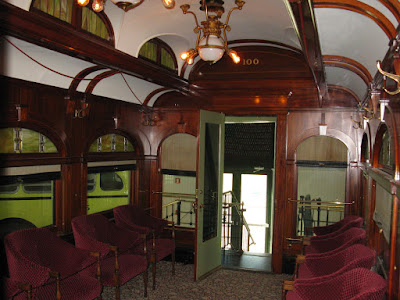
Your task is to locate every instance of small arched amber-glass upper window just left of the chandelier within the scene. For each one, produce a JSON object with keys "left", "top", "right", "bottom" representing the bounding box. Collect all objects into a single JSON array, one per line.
[{"left": 139, "top": 38, "right": 178, "bottom": 73}]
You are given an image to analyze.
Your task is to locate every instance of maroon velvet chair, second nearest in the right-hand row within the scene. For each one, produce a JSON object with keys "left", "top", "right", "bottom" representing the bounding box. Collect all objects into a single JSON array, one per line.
[{"left": 295, "top": 244, "right": 376, "bottom": 279}]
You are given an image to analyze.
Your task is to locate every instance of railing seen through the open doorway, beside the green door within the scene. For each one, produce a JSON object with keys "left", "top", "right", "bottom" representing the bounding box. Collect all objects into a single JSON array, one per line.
[{"left": 221, "top": 191, "right": 255, "bottom": 252}]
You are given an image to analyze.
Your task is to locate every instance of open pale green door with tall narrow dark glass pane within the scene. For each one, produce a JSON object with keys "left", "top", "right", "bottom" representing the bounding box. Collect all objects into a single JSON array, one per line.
[{"left": 195, "top": 110, "right": 225, "bottom": 280}]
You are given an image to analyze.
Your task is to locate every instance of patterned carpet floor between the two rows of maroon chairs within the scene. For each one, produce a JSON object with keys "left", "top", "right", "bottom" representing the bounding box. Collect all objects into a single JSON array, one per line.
[{"left": 103, "top": 261, "right": 291, "bottom": 300}]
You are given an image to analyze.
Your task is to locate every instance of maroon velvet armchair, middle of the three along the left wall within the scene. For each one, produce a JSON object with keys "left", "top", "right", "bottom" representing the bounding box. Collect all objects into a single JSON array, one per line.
[{"left": 71, "top": 214, "right": 148, "bottom": 299}]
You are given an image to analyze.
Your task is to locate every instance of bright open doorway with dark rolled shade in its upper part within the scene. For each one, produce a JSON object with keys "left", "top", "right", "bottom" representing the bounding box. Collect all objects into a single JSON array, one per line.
[{"left": 221, "top": 117, "right": 276, "bottom": 272}]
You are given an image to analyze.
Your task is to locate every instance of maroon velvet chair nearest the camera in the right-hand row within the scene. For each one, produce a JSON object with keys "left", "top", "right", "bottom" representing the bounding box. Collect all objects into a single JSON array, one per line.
[{"left": 286, "top": 268, "right": 387, "bottom": 300}]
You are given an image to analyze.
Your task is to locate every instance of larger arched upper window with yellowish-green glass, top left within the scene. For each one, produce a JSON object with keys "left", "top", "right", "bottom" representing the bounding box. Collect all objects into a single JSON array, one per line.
[{"left": 31, "top": 0, "right": 114, "bottom": 44}]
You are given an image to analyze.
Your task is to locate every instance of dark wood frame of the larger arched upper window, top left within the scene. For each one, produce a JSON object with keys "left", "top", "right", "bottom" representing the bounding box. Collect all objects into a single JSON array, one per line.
[{"left": 30, "top": 0, "right": 115, "bottom": 47}]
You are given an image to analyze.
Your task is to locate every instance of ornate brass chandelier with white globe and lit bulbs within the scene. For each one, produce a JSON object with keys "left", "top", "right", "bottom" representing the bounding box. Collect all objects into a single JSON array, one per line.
[{"left": 181, "top": 0, "right": 245, "bottom": 65}]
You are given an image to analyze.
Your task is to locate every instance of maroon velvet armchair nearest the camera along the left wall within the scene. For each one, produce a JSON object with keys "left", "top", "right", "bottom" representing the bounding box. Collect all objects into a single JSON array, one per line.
[{"left": 4, "top": 228, "right": 102, "bottom": 300}]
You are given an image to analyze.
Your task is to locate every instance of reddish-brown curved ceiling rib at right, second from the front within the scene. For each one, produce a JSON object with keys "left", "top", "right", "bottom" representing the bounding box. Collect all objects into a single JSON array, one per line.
[{"left": 322, "top": 55, "right": 373, "bottom": 86}]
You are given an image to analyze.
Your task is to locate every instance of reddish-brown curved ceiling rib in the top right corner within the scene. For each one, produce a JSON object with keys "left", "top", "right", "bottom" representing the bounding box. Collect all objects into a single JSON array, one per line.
[{"left": 314, "top": 0, "right": 397, "bottom": 40}]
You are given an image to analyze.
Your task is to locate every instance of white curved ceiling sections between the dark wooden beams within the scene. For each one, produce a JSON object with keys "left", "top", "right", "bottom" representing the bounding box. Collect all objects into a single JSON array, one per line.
[{"left": 6, "top": 0, "right": 398, "bottom": 103}]
